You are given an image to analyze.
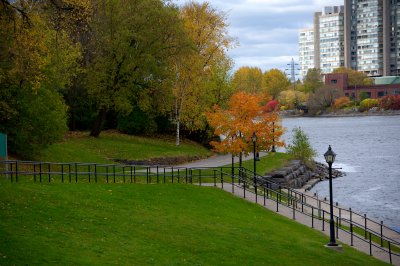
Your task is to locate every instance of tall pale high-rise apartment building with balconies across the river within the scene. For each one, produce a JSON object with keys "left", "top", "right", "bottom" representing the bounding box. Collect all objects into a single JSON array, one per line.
[{"left": 299, "top": 0, "right": 400, "bottom": 76}]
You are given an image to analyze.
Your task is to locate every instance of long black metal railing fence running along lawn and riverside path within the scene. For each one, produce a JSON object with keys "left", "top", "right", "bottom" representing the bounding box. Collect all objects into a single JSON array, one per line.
[{"left": 0, "top": 160, "right": 400, "bottom": 263}]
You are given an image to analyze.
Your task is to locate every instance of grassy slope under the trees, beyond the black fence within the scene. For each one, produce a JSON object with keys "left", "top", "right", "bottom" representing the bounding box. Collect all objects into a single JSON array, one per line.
[{"left": 33, "top": 131, "right": 212, "bottom": 163}]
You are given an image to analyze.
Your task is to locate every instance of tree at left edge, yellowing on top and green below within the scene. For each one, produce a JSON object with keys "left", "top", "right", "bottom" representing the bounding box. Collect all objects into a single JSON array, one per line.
[{"left": 0, "top": 1, "right": 80, "bottom": 157}]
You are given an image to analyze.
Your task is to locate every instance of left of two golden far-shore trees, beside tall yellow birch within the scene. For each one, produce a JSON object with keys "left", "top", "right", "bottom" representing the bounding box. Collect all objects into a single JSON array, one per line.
[{"left": 232, "top": 66, "right": 263, "bottom": 93}]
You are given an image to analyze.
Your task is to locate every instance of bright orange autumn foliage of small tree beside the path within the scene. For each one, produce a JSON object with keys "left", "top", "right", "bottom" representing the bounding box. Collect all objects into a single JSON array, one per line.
[{"left": 207, "top": 92, "right": 284, "bottom": 167}]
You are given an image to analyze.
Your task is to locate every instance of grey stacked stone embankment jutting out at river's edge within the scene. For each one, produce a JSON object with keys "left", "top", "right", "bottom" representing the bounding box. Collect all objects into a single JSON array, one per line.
[{"left": 260, "top": 160, "right": 344, "bottom": 190}]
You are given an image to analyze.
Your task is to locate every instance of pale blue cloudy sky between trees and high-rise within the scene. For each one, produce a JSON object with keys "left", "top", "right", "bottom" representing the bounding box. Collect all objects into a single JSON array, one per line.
[{"left": 174, "top": 0, "right": 344, "bottom": 74}]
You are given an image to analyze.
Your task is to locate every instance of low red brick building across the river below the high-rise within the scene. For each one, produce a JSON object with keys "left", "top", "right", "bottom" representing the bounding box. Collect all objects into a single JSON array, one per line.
[{"left": 325, "top": 73, "right": 400, "bottom": 100}]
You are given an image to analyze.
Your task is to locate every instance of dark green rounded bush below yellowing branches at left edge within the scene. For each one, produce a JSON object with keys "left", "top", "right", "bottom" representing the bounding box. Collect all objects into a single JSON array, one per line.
[{"left": 0, "top": 87, "right": 68, "bottom": 159}]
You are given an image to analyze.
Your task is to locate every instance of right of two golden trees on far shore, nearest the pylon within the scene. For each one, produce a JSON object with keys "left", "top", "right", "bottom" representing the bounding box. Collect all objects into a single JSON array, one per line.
[{"left": 263, "top": 68, "right": 290, "bottom": 99}]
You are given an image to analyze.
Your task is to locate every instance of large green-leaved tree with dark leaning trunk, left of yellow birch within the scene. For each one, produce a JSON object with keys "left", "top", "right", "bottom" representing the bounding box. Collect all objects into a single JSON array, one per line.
[{"left": 86, "top": 0, "right": 185, "bottom": 136}]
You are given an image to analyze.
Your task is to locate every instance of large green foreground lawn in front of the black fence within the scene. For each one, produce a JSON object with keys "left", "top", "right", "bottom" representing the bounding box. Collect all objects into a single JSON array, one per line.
[{"left": 0, "top": 180, "right": 385, "bottom": 265}]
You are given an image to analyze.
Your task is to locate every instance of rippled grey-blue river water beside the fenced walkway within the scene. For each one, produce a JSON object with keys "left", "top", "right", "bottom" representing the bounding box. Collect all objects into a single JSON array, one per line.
[{"left": 282, "top": 116, "right": 400, "bottom": 231}]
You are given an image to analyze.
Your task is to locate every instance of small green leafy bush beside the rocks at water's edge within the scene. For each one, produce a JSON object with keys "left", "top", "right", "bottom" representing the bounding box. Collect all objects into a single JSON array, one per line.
[{"left": 286, "top": 127, "right": 317, "bottom": 166}]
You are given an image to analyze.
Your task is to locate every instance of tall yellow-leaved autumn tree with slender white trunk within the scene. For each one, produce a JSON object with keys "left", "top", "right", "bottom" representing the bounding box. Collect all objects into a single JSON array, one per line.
[{"left": 172, "top": 2, "right": 233, "bottom": 146}]
